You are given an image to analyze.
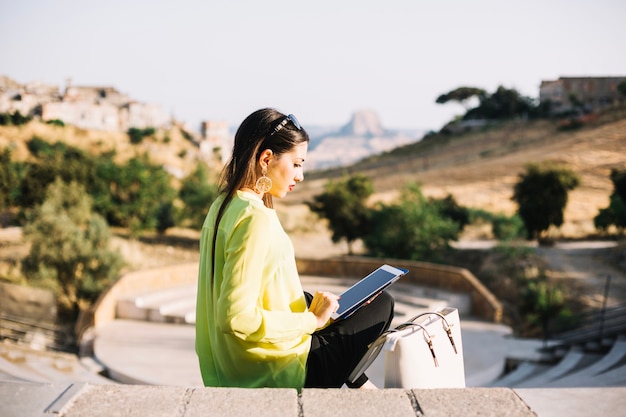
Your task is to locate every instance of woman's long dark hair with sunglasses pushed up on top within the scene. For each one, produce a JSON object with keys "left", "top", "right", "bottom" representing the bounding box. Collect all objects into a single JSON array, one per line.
[{"left": 212, "top": 108, "right": 309, "bottom": 266}]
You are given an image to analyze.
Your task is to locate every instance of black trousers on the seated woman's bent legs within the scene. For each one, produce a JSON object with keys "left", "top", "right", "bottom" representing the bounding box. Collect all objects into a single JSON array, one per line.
[{"left": 304, "top": 291, "right": 394, "bottom": 388}]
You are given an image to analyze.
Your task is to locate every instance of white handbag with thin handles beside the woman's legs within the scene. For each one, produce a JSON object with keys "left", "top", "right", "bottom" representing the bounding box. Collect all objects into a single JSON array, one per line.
[{"left": 349, "top": 307, "right": 465, "bottom": 388}]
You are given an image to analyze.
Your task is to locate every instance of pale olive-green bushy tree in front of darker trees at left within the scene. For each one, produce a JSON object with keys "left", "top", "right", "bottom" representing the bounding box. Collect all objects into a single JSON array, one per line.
[{"left": 22, "top": 179, "right": 123, "bottom": 315}]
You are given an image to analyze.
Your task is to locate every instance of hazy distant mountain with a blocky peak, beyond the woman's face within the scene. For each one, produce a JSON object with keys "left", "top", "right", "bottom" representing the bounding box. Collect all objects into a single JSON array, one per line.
[{"left": 307, "top": 110, "right": 425, "bottom": 169}]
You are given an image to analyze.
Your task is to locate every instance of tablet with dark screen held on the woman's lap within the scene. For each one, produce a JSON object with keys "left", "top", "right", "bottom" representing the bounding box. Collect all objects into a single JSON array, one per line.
[{"left": 331, "top": 264, "right": 409, "bottom": 321}]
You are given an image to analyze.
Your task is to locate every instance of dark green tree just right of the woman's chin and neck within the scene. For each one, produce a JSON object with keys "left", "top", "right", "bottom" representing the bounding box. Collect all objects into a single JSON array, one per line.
[{"left": 307, "top": 175, "right": 374, "bottom": 255}]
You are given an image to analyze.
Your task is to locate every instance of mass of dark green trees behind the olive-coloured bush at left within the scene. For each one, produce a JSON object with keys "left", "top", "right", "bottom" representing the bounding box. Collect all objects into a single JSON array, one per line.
[{"left": 0, "top": 136, "right": 194, "bottom": 237}]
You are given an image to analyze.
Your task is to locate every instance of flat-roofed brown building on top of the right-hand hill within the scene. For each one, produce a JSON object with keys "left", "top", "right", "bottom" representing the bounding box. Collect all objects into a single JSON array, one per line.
[{"left": 539, "top": 76, "right": 626, "bottom": 114}]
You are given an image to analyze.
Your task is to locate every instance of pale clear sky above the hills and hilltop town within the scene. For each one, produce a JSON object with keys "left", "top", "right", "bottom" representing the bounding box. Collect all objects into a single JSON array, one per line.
[{"left": 0, "top": 0, "right": 626, "bottom": 129}]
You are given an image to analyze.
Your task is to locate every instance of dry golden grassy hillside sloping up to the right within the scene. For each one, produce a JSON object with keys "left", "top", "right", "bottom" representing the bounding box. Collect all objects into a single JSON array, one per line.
[{"left": 285, "top": 109, "right": 626, "bottom": 237}]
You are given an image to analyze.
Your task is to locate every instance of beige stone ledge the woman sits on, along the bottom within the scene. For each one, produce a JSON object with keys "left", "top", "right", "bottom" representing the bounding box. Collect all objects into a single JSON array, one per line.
[{"left": 0, "top": 384, "right": 536, "bottom": 417}]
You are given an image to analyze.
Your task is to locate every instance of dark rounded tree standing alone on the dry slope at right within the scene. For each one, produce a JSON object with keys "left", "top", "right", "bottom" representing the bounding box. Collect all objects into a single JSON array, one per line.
[{"left": 512, "top": 164, "right": 580, "bottom": 240}]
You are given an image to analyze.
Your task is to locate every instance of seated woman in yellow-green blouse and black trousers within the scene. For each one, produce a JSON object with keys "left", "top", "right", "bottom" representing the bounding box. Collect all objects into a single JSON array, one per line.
[{"left": 196, "top": 109, "right": 393, "bottom": 389}]
